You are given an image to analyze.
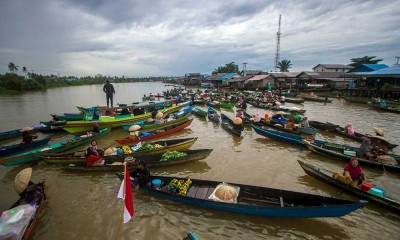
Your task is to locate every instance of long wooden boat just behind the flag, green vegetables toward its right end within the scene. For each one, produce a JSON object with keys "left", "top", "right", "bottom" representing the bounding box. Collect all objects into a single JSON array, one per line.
[{"left": 62, "top": 149, "right": 212, "bottom": 171}]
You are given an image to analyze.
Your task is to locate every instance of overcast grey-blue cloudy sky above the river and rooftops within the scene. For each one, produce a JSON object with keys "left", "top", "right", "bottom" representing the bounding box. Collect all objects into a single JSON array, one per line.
[{"left": 0, "top": 0, "right": 400, "bottom": 76}]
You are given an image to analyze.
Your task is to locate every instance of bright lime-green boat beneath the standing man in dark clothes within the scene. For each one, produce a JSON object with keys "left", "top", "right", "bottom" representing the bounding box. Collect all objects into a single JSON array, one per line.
[{"left": 63, "top": 101, "right": 182, "bottom": 134}]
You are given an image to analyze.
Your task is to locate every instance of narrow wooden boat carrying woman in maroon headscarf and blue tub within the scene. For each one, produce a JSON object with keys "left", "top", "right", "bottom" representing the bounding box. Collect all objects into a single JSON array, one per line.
[{"left": 298, "top": 160, "right": 400, "bottom": 211}]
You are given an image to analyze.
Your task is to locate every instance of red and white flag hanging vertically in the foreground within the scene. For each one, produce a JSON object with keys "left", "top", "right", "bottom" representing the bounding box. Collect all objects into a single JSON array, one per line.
[{"left": 118, "top": 165, "right": 135, "bottom": 223}]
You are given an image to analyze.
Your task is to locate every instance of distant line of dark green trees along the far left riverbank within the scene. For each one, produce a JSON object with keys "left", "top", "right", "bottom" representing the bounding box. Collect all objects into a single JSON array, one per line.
[{"left": 0, "top": 63, "right": 170, "bottom": 93}]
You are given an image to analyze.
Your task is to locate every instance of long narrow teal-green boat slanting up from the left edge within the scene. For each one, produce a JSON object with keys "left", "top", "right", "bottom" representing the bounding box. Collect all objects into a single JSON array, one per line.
[{"left": 0, "top": 129, "right": 110, "bottom": 166}]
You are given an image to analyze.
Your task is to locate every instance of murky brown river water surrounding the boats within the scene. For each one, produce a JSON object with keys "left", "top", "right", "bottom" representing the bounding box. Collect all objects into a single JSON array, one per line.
[{"left": 0, "top": 83, "right": 400, "bottom": 240}]
